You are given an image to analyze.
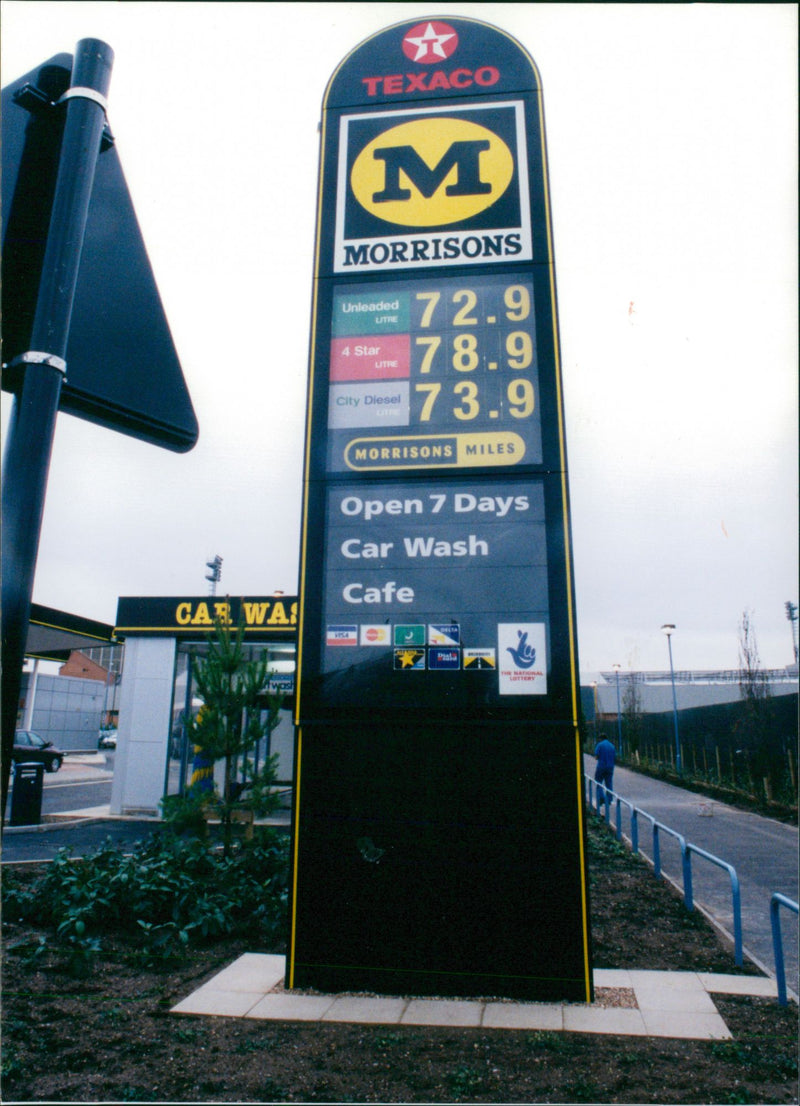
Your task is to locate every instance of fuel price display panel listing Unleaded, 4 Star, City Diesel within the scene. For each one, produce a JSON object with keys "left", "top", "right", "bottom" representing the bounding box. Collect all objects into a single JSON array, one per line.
[{"left": 326, "top": 274, "right": 542, "bottom": 472}]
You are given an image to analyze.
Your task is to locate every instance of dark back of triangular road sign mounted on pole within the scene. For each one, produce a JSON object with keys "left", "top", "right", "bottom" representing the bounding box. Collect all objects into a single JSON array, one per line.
[{"left": 2, "top": 54, "right": 197, "bottom": 452}]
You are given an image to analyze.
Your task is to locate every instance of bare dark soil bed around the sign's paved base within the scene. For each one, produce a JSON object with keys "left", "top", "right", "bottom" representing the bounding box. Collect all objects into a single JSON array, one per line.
[{"left": 2, "top": 817, "right": 798, "bottom": 1103}]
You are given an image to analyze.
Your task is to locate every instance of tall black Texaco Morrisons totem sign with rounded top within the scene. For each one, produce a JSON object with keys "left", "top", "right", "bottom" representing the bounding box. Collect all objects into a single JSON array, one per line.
[{"left": 288, "top": 19, "right": 591, "bottom": 1001}]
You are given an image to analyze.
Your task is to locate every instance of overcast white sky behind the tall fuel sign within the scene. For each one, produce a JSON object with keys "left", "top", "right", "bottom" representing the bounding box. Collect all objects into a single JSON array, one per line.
[{"left": 2, "top": 0, "right": 798, "bottom": 672}]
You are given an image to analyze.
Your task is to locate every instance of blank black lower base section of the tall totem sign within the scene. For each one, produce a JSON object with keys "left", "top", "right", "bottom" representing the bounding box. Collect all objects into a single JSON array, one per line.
[{"left": 289, "top": 722, "right": 591, "bottom": 1002}]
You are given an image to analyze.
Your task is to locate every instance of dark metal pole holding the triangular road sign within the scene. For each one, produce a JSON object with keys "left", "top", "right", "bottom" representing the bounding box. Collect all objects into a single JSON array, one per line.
[{"left": 2, "top": 39, "right": 114, "bottom": 813}]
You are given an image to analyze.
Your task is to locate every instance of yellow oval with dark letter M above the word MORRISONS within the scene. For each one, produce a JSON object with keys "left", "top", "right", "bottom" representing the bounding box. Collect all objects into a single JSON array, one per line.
[{"left": 351, "top": 116, "right": 513, "bottom": 227}]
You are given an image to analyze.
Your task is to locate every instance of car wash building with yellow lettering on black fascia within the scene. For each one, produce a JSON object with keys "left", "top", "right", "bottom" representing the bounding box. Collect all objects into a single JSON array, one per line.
[{"left": 111, "top": 595, "right": 297, "bottom": 815}]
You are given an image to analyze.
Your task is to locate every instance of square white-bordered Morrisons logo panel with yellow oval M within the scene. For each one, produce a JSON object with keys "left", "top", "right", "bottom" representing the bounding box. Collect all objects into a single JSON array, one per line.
[{"left": 334, "top": 102, "right": 532, "bottom": 273}]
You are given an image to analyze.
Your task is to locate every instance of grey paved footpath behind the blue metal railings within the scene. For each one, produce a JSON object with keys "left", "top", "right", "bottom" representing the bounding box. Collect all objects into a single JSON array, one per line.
[{"left": 584, "top": 757, "right": 799, "bottom": 994}]
